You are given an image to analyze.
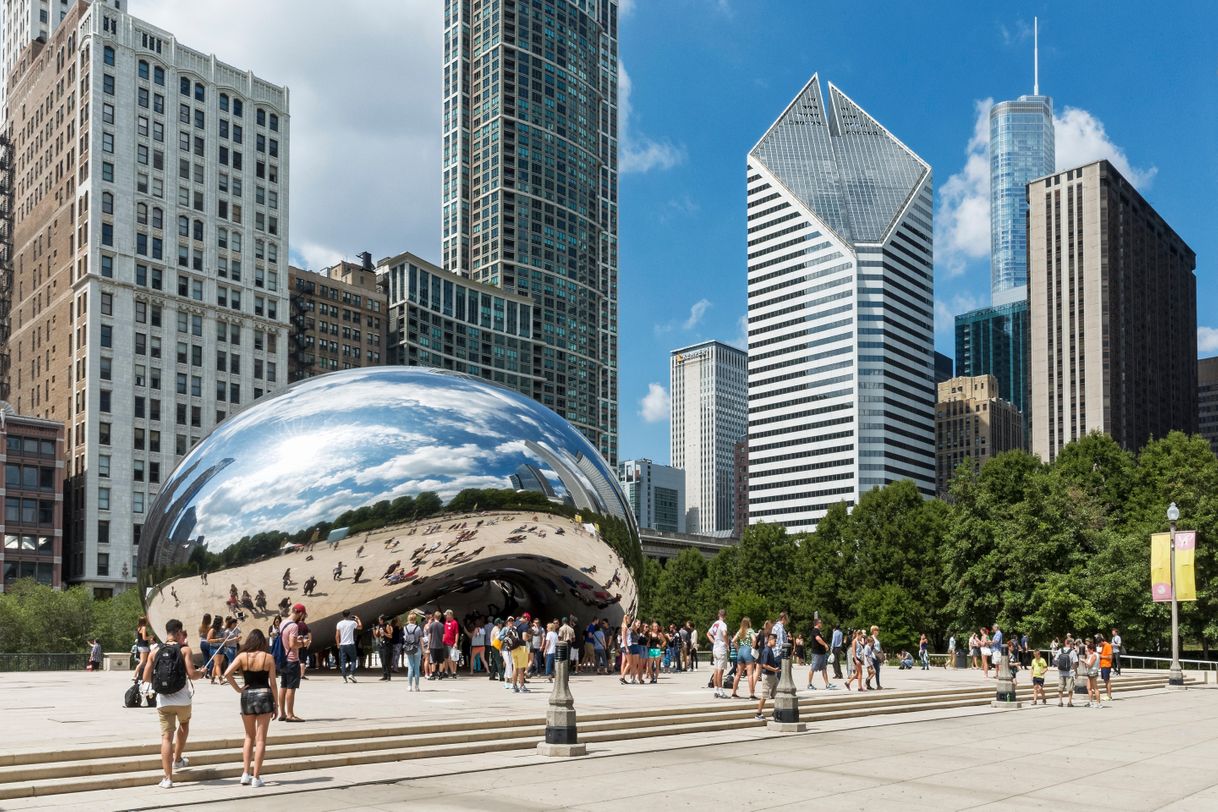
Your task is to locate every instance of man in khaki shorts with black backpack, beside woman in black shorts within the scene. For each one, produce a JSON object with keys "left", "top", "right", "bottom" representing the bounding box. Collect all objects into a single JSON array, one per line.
[{"left": 144, "top": 618, "right": 199, "bottom": 789}]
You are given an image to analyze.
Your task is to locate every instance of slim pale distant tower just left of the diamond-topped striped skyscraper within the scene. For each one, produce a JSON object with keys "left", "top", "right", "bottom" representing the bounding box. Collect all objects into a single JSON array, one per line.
[{"left": 669, "top": 341, "right": 748, "bottom": 536}]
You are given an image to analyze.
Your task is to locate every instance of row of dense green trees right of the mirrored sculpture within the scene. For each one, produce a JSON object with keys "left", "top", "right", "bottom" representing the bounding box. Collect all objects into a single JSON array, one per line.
[{"left": 641, "top": 432, "right": 1218, "bottom": 656}]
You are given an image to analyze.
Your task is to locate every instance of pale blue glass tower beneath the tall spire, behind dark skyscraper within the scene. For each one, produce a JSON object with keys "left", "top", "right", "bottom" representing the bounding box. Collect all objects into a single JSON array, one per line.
[{"left": 987, "top": 95, "right": 1054, "bottom": 301}]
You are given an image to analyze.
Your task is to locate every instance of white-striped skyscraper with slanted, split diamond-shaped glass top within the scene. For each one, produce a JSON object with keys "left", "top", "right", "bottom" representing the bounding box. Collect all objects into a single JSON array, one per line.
[{"left": 747, "top": 75, "right": 934, "bottom": 530}]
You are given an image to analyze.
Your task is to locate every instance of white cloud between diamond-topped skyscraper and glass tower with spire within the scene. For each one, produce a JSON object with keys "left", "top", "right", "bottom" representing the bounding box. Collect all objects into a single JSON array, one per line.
[{"left": 934, "top": 99, "right": 994, "bottom": 276}]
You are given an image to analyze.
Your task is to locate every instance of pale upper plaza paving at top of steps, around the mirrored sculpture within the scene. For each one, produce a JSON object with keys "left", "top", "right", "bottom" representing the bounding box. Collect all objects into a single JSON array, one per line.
[{"left": 0, "top": 665, "right": 974, "bottom": 752}]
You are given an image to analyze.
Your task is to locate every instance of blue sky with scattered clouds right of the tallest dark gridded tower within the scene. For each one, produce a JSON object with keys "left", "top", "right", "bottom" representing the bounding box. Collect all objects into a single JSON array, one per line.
[{"left": 620, "top": 0, "right": 1218, "bottom": 463}]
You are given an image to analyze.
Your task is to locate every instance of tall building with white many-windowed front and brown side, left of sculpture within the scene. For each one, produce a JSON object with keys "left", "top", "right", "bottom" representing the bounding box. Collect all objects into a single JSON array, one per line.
[{"left": 7, "top": 2, "right": 289, "bottom": 594}]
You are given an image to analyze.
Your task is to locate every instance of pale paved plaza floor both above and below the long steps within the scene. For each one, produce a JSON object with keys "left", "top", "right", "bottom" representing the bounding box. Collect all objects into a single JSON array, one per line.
[{"left": 0, "top": 668, "right": 1218, "bottom": 812}]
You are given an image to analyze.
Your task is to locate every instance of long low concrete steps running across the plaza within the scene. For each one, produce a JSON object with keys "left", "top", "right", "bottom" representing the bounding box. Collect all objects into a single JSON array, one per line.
[{"left": 0, "top": 677, "right": 1166, "bottom": 799}]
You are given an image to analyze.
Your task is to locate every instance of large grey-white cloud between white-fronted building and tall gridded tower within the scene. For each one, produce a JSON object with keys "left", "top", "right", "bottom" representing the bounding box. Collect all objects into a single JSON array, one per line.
[{"left": 129, "top": 0, "right": 443, "bottom": 268}]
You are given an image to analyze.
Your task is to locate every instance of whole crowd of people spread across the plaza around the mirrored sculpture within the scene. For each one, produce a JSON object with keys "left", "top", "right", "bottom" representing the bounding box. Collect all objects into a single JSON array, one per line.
[{"left": 134, "top": 603, "right": 1122, "bottom": 788}]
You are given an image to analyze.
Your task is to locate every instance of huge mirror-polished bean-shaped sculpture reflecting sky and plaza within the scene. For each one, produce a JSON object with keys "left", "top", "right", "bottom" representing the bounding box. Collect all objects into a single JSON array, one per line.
[{"left": 139, "top": 366, "right": 642, "bottom": 640}]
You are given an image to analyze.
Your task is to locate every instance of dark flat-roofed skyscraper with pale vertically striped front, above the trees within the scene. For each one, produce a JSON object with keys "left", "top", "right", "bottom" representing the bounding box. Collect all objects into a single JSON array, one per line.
[{"left": 1028, "top": 161, "right": 1197, "bottom": 461}]
